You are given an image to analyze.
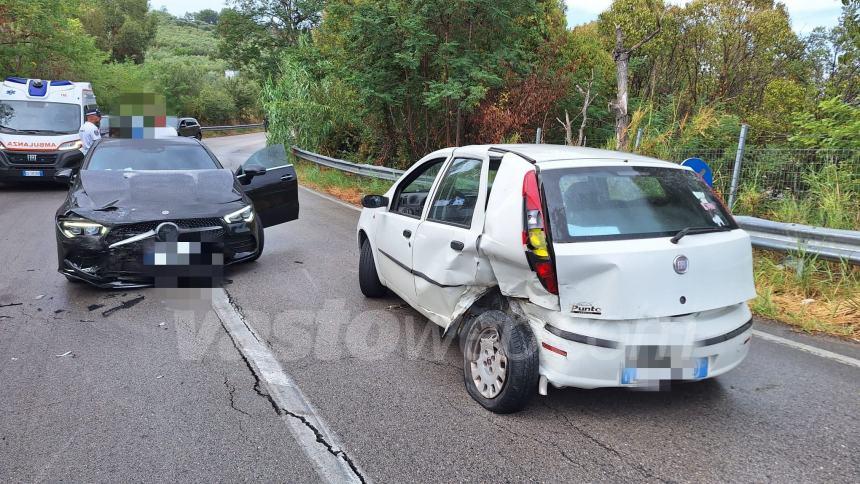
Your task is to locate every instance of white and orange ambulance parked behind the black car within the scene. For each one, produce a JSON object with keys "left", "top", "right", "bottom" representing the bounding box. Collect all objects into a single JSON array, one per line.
[{"left": 0, "top": 77, "right": 96, "bottom": 183}]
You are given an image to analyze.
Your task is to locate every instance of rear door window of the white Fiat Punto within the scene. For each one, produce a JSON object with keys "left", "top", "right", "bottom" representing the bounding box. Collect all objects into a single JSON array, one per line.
[{"left": 427, "top": 158, "right": 483, "bottom": 227}]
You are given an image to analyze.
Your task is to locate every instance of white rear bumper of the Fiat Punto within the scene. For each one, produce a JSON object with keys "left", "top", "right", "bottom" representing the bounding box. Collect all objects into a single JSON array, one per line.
[{"left": 527, "top": 304, "right": 752, "bottom": 388}]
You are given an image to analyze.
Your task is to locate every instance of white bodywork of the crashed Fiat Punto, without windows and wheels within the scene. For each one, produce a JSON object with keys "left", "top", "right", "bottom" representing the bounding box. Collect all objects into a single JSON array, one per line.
[{"left": 358, "top": 145, "right": 755, "bottom": 392}]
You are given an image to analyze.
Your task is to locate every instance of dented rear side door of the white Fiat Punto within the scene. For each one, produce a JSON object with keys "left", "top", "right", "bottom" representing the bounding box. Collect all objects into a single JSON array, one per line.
[{"left": 412, "top": 148, "right": 498, "bottom": 327}]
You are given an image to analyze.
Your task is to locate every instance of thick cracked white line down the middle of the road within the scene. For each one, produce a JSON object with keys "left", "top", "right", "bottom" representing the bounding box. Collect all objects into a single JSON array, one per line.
[{"left": 212, "top": 289, "right": 369, "bottom": 483}]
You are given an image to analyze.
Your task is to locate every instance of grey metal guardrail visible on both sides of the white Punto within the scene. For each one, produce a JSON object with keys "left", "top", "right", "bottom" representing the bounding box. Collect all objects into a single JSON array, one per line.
[{"left": 293, "top": 146, "right": 860, "bottom": 264}]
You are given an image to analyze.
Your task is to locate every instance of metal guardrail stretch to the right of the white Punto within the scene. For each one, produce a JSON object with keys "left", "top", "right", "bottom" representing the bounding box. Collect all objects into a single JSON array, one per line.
[{"left": 735, "top": 216, "right": 860, "bottom": 264}]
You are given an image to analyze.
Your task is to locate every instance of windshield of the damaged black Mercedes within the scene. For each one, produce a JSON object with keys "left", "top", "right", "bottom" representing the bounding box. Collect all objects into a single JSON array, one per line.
[{"left": 86, "top": 139, "right": 221, "bottom": 171}]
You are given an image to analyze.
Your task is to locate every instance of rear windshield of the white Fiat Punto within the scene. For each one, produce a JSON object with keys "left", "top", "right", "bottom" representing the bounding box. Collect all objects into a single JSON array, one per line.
[{"left": 540, "top": 167, "right": 736, "bottom": 242}]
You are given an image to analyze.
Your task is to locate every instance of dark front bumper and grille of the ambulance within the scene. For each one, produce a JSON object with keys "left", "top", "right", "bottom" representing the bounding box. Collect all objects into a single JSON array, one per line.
[{"left": 0, "top": 150, "right": 84, "bottom": 183}]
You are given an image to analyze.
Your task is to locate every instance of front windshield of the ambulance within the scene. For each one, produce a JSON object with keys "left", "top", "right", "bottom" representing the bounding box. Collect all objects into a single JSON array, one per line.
[{"left": 0, "top": 101, "right": 83, "bottom": 134}]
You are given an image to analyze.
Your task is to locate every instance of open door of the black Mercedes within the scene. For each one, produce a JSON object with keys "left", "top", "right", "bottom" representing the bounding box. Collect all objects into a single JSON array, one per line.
[{"left": 236, "top": 145, "right": 299, "bottom": 227}]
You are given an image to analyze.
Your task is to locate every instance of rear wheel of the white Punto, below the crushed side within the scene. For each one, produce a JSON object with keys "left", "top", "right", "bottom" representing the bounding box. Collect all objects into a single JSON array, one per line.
[{"left": 460, "top": 310, "right": 539, "bottom": 414}]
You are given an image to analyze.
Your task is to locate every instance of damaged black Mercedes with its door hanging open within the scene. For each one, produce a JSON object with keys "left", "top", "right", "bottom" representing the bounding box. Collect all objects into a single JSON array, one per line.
[{"left": 56, "top": 137, "right": 299, "bottom": 288}]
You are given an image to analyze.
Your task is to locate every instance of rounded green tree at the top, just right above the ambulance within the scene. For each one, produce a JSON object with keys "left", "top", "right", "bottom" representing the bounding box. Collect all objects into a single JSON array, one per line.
[{"left": 80, "top": 0, "right": 158, "bottom": 64}]
